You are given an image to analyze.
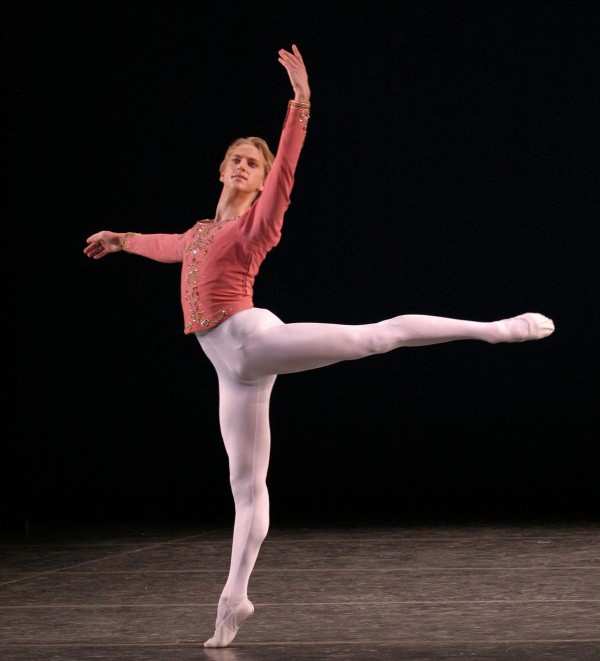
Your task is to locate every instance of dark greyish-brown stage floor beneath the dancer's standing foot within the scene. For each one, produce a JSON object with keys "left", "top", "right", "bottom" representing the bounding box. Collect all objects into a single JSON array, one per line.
[{"left": 0, "top": 522, "right": 600, "bottom": 661}]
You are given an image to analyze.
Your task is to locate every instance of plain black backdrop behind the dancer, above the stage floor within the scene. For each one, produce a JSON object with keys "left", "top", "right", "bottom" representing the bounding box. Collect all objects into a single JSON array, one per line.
[{"left": 2, "top": 0, "right": 600, "bottom": 528}]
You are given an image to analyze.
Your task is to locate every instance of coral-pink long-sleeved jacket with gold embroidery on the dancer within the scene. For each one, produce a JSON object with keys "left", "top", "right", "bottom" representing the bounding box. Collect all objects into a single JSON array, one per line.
[{"left": 125, "top": 102, "right": 309, "bottom": 334}]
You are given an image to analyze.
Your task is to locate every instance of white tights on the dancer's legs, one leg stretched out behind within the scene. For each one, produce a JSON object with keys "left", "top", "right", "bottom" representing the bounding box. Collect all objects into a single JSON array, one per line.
[{"left": 196, "top": 308, "right": 554, "bottom": 627}]
